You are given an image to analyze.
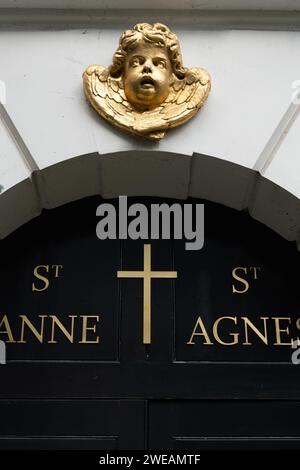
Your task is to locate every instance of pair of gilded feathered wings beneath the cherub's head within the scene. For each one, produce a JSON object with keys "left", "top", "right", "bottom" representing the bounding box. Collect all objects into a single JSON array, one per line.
[{"left": 83, "top": 65, "right": 210, "bottom": 140}]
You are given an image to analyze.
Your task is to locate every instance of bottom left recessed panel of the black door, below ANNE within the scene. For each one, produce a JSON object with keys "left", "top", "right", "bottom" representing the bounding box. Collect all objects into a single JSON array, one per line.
[{"left": 0, "top": 400, "right": 145, "bottom": 450}]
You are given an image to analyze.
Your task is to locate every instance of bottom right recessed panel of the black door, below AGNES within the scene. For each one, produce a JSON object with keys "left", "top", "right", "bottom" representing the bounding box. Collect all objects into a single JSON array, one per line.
[{"left": 149, "top": 400, "right": 300, "bottom": 451}]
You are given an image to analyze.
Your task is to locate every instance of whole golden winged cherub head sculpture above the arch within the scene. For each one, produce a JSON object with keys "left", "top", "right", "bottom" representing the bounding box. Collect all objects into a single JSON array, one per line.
[{"left": 83, "top": 23, "right": 211, "bottom": 140}]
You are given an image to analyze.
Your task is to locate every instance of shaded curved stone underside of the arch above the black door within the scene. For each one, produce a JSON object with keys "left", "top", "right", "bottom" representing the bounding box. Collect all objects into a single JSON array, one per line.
[{"left": 0, "top": 150, "right": 300, "bottom": 252}]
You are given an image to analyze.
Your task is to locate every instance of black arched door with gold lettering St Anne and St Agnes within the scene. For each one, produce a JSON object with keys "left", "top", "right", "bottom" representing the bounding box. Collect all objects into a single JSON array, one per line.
[{"left": 0, "top": 198, "right": 300, "bottom": 450}]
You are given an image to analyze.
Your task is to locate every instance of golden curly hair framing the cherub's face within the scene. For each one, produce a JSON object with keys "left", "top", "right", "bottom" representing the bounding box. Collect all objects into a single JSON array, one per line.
[{"left": 109, "top": 23, "right": 187, "bottom": 79}]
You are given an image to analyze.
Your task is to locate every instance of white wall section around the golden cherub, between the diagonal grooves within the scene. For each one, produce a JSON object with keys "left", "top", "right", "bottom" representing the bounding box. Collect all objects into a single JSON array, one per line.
[{"left": 0, "top": 28, "right": 300, "bottom": 169}]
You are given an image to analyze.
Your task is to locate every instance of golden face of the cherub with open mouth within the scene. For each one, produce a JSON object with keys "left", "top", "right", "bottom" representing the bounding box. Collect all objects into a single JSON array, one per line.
[{"left": 124, "top": 41, "right": 173, "bottom": 110}]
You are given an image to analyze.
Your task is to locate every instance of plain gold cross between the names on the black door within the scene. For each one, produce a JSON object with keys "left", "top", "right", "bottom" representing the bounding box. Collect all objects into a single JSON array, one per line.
[{"left": 118, "top": 245, "right": 177, "bottom": 344}]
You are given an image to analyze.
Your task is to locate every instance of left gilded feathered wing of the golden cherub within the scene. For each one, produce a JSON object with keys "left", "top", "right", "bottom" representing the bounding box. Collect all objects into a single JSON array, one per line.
[{"left": 83, "top": 65, "right": 134, "bottom": 129}]
